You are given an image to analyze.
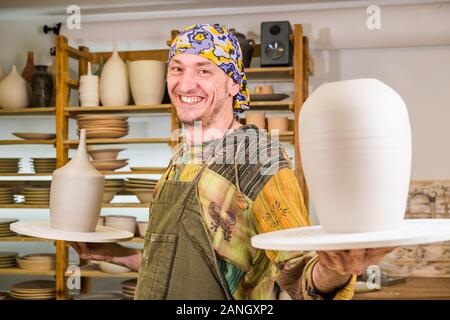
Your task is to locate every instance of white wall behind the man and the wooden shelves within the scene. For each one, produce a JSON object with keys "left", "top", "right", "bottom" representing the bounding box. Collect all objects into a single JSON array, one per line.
[{"left": 0, "top": 4, "right": 450, "bottom": 290}]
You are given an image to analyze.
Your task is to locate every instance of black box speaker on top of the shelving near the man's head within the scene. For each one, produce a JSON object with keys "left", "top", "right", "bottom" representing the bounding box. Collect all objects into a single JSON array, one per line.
[{"left": 261, "top": 21, "right": 293, "bottom": 67}]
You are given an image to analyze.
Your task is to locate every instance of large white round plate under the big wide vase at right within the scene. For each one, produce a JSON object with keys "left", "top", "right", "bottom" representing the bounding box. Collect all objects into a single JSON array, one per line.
[{"left": 252, "top": 219, "right": 450, "bottom": 251}]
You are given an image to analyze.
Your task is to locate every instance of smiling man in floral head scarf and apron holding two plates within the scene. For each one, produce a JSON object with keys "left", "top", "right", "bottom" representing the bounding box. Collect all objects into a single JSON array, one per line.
[{"left": 72, "top": 24, "right": 391, "bottom": 299}]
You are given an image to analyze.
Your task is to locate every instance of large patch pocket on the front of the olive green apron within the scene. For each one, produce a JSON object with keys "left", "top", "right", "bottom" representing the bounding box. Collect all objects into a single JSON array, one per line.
[{"left": 135, "top": 233, "right": 178, "bottom": 299}]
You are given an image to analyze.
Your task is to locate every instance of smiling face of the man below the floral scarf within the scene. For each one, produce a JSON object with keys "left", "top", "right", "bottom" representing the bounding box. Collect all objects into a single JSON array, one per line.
[{"left": 167, "top": 54, "right": 239, "bottom": 126}]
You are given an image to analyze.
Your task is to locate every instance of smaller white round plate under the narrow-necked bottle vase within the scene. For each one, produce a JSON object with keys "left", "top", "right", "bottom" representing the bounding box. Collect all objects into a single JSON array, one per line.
[{"left": 11, "top": 221, "right": 134, "bottom": 242}]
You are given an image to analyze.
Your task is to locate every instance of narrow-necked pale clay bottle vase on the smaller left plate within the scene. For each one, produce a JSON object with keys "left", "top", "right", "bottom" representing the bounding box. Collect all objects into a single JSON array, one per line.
[{"left": 50, "top": 129, "right": 105, "bottom": 232}]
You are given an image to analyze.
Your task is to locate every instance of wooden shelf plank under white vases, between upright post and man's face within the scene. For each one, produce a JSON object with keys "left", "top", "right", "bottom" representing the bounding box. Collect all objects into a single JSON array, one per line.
[{"left": 65, "top": 103, "right": 172, "bottom": 117}]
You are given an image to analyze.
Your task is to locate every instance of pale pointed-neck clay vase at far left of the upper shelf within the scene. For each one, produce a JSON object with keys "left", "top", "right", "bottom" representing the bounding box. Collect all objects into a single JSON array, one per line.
[{"left": 0, "top": 66, "right": 31, "bottom": 109}]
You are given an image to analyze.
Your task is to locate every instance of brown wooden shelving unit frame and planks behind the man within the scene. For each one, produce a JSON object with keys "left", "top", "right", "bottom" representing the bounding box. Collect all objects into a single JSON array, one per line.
[{"left": 0, "top": 25, "right": 312, "bottom": 300}]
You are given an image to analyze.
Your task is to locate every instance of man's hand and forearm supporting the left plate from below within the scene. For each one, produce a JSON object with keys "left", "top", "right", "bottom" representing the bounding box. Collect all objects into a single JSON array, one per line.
[{"left": 68, "top": 242, "right": 142, "bottom": 271}]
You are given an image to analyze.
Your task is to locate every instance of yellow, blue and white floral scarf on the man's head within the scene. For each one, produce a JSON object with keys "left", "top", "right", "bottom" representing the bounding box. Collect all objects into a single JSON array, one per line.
[{"left": 169, "top": 24, "right": 250, "bottom": 113}]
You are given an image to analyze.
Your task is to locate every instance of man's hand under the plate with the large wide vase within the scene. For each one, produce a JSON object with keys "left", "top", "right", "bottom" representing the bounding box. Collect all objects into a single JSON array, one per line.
[{"left": 313, "top": 247, "right": 395, "bottom": 293}]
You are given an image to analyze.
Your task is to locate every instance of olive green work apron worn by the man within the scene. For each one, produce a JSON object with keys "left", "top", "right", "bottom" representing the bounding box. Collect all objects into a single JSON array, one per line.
[{"left": 134, "top": 146, "right": 232, "bottom": 300}]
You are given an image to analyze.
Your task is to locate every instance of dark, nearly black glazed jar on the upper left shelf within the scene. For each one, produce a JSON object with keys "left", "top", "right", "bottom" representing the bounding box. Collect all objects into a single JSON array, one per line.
[{"left": 31, "top": 65, "right": 53, "bottom": 107}]
